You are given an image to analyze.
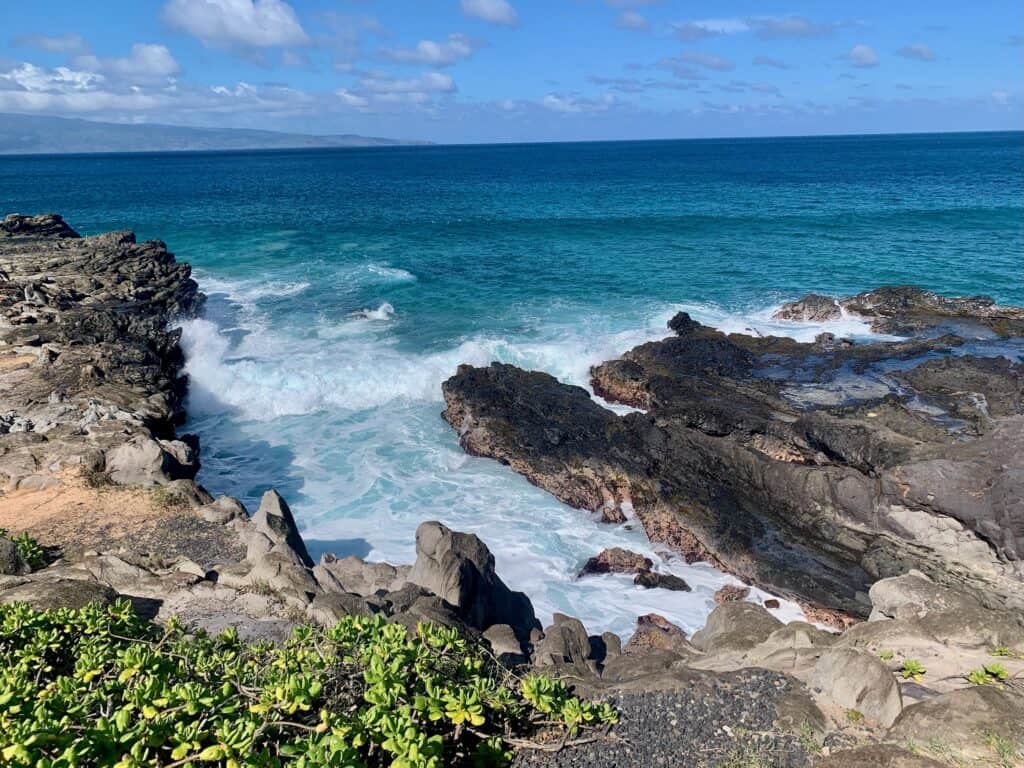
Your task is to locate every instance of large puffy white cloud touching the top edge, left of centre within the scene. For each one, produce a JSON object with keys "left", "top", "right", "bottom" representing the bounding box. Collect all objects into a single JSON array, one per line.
[{"left": 163, "top": 0, "right": 309, "bottom": 48}]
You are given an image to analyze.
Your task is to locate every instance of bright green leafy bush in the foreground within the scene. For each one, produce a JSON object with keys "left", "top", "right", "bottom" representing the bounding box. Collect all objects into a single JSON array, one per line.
[{"left": 0, "top": 601, "right": 616, "bottom": 768}]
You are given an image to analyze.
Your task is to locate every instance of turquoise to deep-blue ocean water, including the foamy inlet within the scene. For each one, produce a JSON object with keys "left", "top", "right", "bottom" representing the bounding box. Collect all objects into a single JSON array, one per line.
[{"left": 0, "top": 133, "right": 1024, "bottom": 634}]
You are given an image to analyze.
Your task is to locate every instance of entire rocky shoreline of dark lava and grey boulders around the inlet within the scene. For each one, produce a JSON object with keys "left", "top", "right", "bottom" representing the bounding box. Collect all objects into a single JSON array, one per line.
[{"left": 0, "top": 215, "right": 1024, "bottom": 768}]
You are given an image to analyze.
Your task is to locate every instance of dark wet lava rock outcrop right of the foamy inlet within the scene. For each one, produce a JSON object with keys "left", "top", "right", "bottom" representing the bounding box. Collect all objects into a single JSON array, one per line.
[{"left": 443, "top": 289, "right": 1024, "bottom": 617}]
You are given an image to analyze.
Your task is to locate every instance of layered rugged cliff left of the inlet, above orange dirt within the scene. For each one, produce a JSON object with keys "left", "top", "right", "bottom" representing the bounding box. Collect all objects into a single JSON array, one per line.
[{"left": 0, "top": 215, "right": 203, "bottom": 492}]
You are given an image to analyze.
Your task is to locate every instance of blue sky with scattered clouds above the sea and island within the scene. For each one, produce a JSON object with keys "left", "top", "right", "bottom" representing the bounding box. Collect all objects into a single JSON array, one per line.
[{"left": 0, "top": 0, "right": 1024, "bottom": 142}]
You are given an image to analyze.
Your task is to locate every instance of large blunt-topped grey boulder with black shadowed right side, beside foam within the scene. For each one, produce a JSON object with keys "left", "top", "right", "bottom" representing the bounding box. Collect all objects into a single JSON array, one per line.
[{"left": 409, "top": 522, "right": 538, "bottom": 641}]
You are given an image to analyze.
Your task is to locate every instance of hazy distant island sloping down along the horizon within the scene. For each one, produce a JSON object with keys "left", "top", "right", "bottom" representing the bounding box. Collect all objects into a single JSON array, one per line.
[{"left": 0, "top": 113, "right": 430, "bottom": 155}]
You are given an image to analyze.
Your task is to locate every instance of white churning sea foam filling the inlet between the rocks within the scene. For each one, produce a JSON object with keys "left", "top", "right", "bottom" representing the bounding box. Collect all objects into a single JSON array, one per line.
[{"left": 182, "top": 282, "right": 888, "bottom": 635}]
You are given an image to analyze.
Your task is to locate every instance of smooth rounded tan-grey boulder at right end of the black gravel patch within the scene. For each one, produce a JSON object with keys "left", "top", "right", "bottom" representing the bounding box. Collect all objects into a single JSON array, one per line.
[{"left": 807, "top": 648, "right": 903, "bottom": 727}]
